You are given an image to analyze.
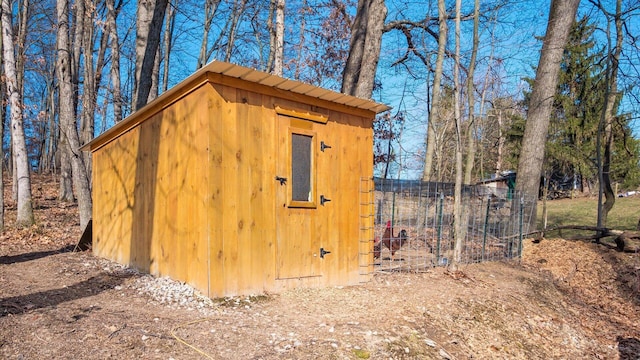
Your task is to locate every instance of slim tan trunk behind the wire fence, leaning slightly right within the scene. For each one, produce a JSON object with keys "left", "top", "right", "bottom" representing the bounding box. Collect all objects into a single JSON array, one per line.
[{"left": 422, "top": 0, "right": 448, "bottom": 181}]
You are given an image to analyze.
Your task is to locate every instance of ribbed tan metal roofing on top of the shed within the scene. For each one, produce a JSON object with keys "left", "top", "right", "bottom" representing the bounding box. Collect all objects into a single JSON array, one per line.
[{"left": 205, "top": 61, "right": 390, "bottom": 114}]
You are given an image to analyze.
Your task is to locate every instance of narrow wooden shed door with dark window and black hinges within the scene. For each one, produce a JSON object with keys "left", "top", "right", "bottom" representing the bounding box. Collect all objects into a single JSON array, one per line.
[{"left": 274, "top": 115, "right": 324, "bottom": 279}]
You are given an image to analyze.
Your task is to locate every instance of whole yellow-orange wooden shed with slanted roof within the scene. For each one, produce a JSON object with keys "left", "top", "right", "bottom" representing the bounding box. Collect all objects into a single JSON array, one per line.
[{"left": 83, "top": 62, "right": 388, "bottom": 297}]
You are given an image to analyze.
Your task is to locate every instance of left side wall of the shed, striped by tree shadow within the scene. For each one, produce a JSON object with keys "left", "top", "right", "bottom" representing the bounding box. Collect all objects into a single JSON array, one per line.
[{"left": 93, "top": 87, "right": 211, "bottom": 293}]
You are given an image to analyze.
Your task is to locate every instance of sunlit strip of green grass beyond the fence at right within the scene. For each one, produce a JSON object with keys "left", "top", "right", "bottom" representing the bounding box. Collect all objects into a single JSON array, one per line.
[{"left": 538, "top": 196, "right": 640, "bottom": 236}]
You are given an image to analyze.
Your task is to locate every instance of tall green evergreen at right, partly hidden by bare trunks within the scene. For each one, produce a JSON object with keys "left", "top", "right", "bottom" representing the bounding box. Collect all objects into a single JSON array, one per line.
[{"left": 508, "top": 18, "right": 640, "bottom": 197}]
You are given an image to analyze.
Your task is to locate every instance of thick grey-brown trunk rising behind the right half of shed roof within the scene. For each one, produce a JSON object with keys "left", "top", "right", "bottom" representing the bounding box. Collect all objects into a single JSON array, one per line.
[{"left": 342, "top": 0, "right": 387, "bottom": 99}]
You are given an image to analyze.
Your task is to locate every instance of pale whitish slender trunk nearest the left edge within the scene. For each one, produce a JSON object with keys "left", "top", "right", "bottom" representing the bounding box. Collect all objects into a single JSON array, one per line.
[{"left": 2, "top": 0, "right": 34, "bottom": 227}]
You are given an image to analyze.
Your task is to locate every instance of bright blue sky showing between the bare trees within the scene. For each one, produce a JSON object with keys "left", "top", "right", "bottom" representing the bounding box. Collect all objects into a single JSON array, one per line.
[{"left": 91, "top": 0, "right": 640, "bottom": 178}]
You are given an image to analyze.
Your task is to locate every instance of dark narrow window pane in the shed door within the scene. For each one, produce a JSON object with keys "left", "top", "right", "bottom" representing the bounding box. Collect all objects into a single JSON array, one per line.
[{"left": 291, "top": 134, "right": 313, "bottom": 201}]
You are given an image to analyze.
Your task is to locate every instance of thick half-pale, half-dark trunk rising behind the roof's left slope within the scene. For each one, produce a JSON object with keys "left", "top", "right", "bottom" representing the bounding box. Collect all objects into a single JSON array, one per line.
[{"left": 133, "top": 0, "right": 168, "bottom": 110}]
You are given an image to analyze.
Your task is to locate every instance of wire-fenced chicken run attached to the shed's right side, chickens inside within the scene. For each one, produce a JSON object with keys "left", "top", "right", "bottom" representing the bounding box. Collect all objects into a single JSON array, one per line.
[{"left": 361, "top": 178, "right": 532, "bottom": 272}]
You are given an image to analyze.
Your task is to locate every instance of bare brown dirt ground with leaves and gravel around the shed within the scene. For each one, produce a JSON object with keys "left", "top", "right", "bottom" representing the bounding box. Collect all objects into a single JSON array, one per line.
[{"left": 0, "top": 174, "right": 640, "bottom": 359}]
